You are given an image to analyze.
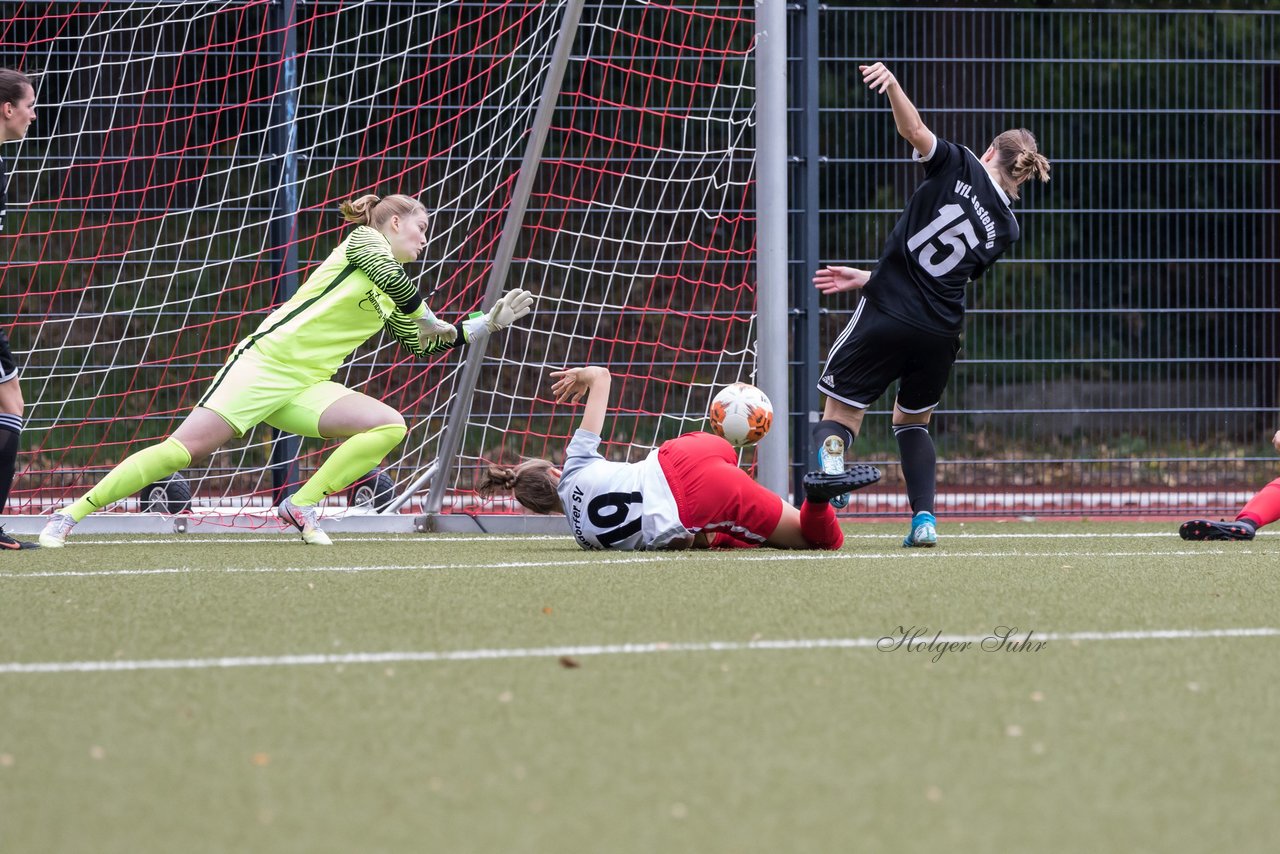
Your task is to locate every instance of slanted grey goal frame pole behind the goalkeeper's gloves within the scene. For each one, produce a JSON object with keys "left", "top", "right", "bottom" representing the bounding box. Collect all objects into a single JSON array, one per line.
[{"left": 425, "top": 0, "right": 584, "bottom": 515}]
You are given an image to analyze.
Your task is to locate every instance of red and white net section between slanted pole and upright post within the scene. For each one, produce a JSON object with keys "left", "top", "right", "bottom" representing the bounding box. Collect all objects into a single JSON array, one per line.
[{"left": 419, "top": 4, "right": 768, "bottom": 530}]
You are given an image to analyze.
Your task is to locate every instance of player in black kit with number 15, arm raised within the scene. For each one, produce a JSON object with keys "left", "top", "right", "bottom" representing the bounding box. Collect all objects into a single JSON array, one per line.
[{"left": 813, "top": 63, "right": 1050, "bottom": 547}]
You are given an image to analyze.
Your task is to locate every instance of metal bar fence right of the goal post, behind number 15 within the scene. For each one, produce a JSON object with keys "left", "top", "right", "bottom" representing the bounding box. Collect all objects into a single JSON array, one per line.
[{"left": 791, "top": 3, "right": 1280, "bottom": 515}]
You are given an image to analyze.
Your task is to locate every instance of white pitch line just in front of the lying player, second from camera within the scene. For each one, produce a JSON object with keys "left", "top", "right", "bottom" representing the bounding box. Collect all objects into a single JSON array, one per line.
[{"left": 0, "top": 548, "right": 1254, "bottom": 581}]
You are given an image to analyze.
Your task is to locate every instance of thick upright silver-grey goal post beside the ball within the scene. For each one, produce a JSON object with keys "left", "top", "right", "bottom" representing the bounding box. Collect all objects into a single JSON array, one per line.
[{"left": 755, "top": 0, "right": 791, "bottom": 499}]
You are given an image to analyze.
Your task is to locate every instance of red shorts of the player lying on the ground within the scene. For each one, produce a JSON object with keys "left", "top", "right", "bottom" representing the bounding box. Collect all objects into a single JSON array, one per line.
[{"left": 658, "top": 433, "right": 782, "bottom": 543}]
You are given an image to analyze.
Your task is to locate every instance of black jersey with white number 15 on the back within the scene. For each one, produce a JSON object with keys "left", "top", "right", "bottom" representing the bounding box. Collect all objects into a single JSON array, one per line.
[{"left": 863, "top": 138, "right": 1018, "bottom": 335}]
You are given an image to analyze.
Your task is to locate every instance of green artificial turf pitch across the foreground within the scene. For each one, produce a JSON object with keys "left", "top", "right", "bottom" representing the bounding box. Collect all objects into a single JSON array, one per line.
[{"left": 0, "top": 524, "right": 1280, "bottom": 854}]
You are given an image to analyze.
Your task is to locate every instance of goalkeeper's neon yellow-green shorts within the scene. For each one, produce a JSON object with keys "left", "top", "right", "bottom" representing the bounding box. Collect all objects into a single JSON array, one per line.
[{"left": 197, "top": 350, "right": 356, "bottom": 439}]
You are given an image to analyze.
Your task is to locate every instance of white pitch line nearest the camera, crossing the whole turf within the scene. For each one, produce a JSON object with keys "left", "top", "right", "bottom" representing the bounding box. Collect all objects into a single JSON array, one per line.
[{"left": 0, "top": 629, "right": 1280, "bottom": 676}]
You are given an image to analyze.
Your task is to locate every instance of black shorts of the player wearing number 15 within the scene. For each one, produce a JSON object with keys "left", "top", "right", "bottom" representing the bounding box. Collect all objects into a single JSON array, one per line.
[{"left": 818, "top": 298, "right": 960, "bottom": 412}]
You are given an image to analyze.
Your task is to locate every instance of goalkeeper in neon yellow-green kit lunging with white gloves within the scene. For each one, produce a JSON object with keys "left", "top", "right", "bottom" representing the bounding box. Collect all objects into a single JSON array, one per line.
[{"left": 40, "top": 196, "right": 534, "bottom": 548}]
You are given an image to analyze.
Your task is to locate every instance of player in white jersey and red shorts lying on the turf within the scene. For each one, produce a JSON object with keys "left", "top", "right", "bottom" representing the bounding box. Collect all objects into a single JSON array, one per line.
[{"left": 480, "top": 366, "right": 881, "bottom": 549}]
